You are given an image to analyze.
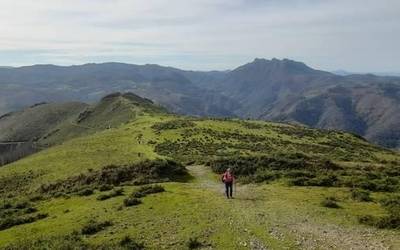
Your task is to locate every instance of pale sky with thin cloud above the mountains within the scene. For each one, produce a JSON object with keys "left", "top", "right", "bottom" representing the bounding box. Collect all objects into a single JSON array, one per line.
[{"left": 0, "top": 0, "right": 400, "bottom": 72}]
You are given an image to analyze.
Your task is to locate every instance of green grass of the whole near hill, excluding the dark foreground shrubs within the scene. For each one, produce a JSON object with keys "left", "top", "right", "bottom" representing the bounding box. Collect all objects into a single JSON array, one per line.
[{"left": 0, "top": 114, "right": 400, "bottom": 249}]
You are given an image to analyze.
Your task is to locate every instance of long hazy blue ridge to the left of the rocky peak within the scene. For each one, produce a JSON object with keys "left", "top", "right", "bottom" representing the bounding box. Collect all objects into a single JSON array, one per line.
[{"left": 0, "top": 63, "right": 235, "bottom": 116}]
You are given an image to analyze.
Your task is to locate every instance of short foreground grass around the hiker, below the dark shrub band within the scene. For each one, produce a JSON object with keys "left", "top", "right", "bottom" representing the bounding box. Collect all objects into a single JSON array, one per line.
[{"left": 0, "top": 168, "right": 396, "bottom": 249}]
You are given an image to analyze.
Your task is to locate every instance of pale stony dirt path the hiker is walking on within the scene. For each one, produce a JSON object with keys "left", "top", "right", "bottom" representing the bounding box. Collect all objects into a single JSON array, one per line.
[{"left": 187, "top": 166, "right": 399, "bottom": 250}]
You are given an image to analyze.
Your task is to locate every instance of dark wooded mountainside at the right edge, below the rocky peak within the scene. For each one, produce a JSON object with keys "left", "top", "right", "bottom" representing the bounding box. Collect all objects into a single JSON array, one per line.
[{"left": 261, "top": 84, "right": 400, "bottom": 148}]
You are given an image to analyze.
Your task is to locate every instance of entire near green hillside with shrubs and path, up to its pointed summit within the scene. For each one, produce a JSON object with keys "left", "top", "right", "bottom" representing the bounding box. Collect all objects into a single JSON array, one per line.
[{"left": 0, "top": 94, "right": 400, "bottom": 249}]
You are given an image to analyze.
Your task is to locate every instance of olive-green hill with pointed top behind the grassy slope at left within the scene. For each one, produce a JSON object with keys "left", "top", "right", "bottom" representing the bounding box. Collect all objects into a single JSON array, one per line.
[{"left": 0, "top": 93, "right": 165, "bottom": 146}]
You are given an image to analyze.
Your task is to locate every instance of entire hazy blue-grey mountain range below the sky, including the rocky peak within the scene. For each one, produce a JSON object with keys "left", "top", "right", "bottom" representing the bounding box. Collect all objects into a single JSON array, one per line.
[{"left": 0, "top": 59, "right": 400, "bottom": 148}]
